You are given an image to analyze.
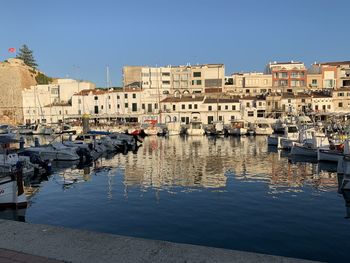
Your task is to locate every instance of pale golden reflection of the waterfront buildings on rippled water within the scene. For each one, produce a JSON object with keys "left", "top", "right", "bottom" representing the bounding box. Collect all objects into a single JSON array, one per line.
[{"left": 102, "top": 136, "right": 337, "bottom": 193}]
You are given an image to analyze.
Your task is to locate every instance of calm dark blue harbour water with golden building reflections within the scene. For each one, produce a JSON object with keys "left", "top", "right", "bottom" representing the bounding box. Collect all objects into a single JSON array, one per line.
[{"left": 0, "top": 137, "right": 350, "bottom": 262}]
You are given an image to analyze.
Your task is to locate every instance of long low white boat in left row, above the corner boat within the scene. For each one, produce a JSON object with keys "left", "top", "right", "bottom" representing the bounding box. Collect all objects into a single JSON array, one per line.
[{"left": 23, "top": 142, "right": 80, "bottom": 161}]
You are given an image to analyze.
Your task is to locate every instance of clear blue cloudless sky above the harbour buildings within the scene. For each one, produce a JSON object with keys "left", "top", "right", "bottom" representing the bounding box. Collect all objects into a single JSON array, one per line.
[{"left": 0, "top": 0, "right": 350, "bottom": 86}]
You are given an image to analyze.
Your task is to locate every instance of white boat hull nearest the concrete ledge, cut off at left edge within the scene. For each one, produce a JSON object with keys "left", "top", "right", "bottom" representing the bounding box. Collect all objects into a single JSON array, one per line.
[{"left": 0, "top": 170, "right": 27, "bottom": 208}]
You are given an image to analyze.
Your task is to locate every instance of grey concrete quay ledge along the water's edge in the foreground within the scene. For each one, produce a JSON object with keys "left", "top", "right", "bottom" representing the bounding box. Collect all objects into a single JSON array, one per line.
[{"left": 0, "top": 220, "right": 318, "bottom": 263}]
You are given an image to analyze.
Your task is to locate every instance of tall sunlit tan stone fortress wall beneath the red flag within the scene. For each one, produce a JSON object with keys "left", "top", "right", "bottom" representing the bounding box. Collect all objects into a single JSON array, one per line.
[{"left": 0, "top": 58, "right": 37, "bottom": 124}]
